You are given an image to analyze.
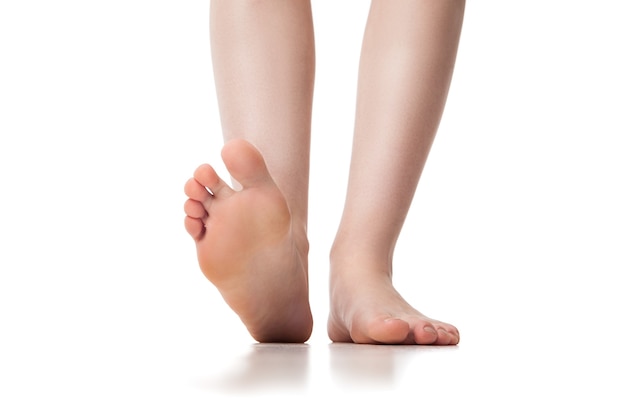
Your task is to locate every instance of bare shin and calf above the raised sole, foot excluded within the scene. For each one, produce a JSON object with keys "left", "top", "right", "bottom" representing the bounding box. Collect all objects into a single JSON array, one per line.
[{"left": 211, "top": 0, "right": 315, "bottom": 226}]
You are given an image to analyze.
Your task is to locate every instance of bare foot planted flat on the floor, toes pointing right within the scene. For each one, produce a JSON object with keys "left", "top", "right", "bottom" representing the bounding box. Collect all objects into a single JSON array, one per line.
[{"left": 328, "top": 267, "right": 459, "bottom": 345}]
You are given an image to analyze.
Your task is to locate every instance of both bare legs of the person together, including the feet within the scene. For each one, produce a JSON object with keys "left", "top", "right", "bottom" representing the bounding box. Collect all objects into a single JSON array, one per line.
[{"left": 185, "top": 0, "right": 464, "bottom": 345}]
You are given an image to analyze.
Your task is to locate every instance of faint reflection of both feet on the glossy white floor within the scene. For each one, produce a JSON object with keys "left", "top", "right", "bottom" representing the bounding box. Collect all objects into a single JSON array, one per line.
[{"left": 203, "top": 343, "right": 459, "bottom": 393}]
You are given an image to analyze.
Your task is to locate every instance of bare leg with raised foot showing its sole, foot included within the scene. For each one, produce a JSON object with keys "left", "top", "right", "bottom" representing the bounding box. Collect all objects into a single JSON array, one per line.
[{"left": 185, "top": 0, "right": 315, "bottom": 342}]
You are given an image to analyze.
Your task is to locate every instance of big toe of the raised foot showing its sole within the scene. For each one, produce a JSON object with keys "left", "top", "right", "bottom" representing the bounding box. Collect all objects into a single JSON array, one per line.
[{"left": 222, "top": 139, "right": 272, "bottom": 188}]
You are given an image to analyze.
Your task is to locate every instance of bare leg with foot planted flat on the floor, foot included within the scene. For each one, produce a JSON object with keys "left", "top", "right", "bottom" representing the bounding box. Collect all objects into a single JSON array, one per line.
[{"left": 328, "top": 0, "right": 464, "bottom": 344}]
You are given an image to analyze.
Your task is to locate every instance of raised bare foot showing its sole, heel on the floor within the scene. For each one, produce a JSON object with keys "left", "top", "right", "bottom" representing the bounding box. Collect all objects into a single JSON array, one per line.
[{"left": 185, "top": 140, "right": 313, "bottom": 342}]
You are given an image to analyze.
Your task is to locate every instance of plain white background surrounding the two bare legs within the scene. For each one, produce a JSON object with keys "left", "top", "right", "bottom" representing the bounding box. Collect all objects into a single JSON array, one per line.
[{"left": 0, "top": 0, "right": 626, "bottom": 414}]
